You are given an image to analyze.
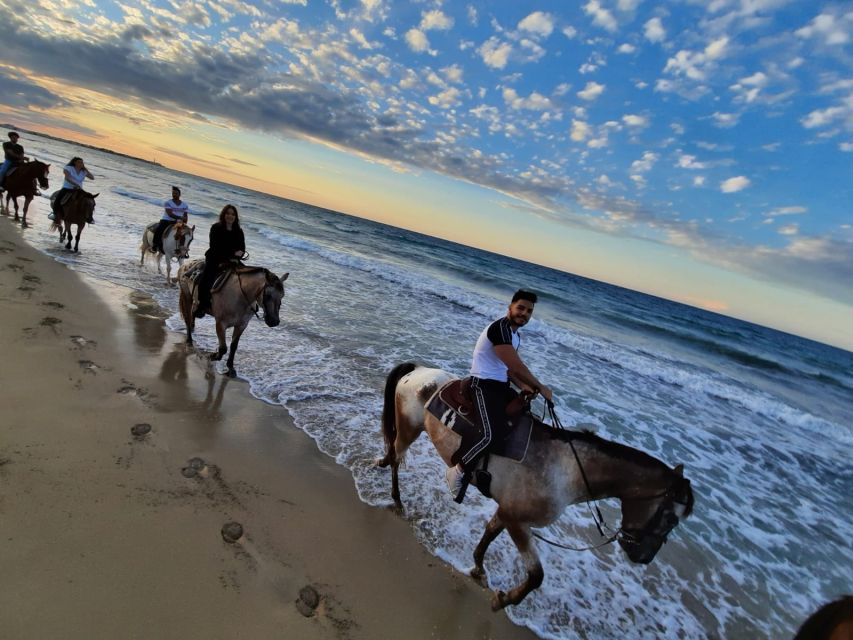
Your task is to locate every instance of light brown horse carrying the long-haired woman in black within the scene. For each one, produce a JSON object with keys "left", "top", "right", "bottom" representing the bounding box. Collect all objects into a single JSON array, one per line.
[{"left": 178, "top": 259, "right": 290, "bottom": 378}]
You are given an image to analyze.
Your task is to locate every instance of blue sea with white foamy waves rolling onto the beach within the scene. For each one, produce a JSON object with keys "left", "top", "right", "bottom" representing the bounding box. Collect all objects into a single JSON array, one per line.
[{"left": 13, "top": 134, "right": 853, "bottom": 639}]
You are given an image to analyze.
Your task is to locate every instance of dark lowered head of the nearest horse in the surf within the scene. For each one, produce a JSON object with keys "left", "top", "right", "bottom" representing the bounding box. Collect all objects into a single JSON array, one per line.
[{"left": 618, "top": 465, "right": 693, "bottom": 564}]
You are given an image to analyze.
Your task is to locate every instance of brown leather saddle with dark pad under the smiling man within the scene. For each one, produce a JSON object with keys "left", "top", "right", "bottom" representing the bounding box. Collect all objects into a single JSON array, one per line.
[{"left": 427, "top": 378, "right": 533, "bottom": 463}]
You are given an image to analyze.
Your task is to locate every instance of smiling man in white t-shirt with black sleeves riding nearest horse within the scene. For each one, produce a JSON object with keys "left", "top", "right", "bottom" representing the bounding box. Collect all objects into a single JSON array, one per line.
[{"left": 445, "top": 289, "right": 551, "bottom": 502}]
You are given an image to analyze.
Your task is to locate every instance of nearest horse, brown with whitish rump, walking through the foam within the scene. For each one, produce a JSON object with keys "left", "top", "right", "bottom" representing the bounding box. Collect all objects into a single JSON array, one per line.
[{"left": 376, "top": 362, "right": 693, "bottom": 611}]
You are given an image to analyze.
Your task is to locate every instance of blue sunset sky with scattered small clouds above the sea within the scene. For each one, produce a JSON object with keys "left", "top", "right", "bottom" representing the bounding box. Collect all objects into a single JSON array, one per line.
[{"left": 0, "top": 0, "right": 853, "bottom": 350}]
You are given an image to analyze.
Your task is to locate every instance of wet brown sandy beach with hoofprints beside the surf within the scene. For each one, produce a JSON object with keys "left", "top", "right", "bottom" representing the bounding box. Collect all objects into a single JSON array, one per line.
[{"left": 0, "top": 219, "right": 534, "bottom": 639}]
